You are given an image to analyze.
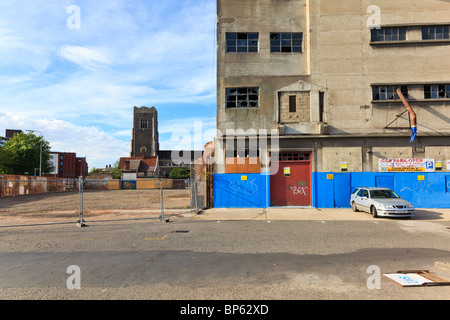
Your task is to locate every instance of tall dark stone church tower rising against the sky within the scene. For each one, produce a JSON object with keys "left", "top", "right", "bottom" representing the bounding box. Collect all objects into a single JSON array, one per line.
[{"left": 130, "top": 107, "right": 159, "bottom": 157}]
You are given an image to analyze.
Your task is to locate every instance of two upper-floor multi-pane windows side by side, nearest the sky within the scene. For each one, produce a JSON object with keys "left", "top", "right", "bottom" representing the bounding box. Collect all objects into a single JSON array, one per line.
[{"left": 226, "top": 32, "right": 303, "bottom": 53}]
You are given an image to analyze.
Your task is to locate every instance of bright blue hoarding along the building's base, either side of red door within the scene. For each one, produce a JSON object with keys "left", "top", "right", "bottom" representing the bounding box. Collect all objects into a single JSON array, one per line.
[{"left": 214, "top": 172, "right": 450, "bottom": 208}]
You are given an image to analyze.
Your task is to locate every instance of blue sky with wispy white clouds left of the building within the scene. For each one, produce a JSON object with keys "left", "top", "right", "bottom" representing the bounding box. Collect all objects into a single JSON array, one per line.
[{"left": 0, "top": 0, "right": 216, "bottom": 169}]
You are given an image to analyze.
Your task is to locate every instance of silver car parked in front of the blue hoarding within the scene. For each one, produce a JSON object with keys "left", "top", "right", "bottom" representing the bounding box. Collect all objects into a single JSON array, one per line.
[{"left": 350, "top": 187, "right": 415, "bottom": 218}]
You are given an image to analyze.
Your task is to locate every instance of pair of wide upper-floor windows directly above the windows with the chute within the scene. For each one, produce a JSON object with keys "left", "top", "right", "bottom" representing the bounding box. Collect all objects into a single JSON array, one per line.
[{"left": 371, "top": 26, "right": 450, "bottom": 42}]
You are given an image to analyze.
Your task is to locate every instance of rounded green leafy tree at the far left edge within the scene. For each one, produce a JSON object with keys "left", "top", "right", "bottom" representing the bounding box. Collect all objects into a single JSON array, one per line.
[{"left": 0, "top": 132, "right": 53, "bottom": 174}]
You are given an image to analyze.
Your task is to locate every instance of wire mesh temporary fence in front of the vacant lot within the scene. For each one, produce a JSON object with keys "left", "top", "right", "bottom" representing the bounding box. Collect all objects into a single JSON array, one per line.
[{"left": 0, "top": 177, "right": 205, "bottom": 225}]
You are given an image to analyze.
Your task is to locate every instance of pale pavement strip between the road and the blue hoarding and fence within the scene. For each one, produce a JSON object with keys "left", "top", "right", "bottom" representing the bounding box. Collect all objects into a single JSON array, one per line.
[{"left": 0, "top": 207, "right": 450, "bottom": 227}]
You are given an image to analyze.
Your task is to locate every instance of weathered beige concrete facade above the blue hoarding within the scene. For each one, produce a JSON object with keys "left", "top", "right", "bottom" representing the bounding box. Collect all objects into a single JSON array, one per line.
[{"left": 215, "top": 0, "right": 450, "bottom": 209}]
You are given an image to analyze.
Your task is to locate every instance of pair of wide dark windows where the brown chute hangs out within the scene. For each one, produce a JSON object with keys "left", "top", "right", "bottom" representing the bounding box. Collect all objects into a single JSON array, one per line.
[{"left": 372, "top": 84, "right": 450, "bottom": 101}]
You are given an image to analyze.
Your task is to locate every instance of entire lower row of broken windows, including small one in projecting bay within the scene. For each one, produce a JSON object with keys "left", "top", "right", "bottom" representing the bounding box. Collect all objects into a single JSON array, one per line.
[{"left": 225, "top": 84, "right": 450, "bottom": 112}]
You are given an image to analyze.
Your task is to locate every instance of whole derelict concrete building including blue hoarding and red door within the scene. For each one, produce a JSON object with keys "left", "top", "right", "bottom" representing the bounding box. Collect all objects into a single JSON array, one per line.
[{"left": 215, "top": 0, "right": 450, "bottom": 207}]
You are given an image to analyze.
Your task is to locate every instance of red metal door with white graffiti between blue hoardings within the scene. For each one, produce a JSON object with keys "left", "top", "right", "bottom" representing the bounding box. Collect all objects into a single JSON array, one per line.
[{"left": 270, "top": 153, "right": 311, "bottom": 206}]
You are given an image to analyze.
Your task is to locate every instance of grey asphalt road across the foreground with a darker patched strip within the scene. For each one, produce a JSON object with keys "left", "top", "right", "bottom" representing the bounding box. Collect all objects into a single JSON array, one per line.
[{"left": 0, "top": 218, "right": 450, "bottom": 300}]
